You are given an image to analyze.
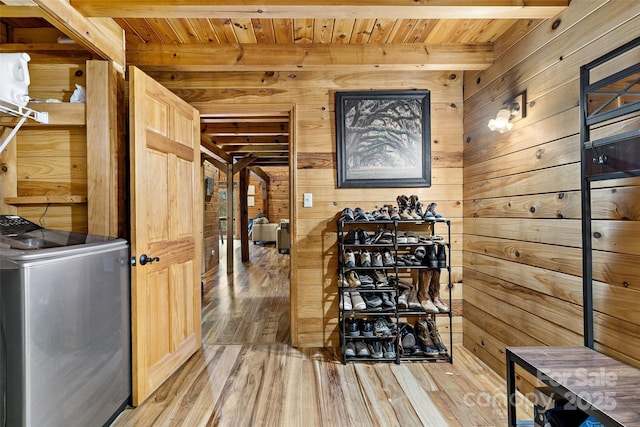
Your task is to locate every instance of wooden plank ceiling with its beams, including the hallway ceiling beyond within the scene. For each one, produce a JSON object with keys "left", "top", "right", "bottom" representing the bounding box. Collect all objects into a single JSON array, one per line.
[{"left": 0, "top": 0, "right": 569, "bottom": 166}]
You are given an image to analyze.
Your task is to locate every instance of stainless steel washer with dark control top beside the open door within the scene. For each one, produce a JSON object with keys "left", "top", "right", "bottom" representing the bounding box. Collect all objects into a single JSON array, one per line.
[{"left": 0, "top": 215, "right": 131, "bottom": 427}]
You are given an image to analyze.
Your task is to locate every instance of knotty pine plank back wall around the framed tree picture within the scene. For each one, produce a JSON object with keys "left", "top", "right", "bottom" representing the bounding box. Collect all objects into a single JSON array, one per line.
[{"left": 149, "top": 71, "right": 463, "bottom": 346}]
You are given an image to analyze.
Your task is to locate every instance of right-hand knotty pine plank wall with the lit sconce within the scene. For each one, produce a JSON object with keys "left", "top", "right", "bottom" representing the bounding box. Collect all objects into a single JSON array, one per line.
[{"left": 463, "top": 0, "right": 640, "bottom": 392}]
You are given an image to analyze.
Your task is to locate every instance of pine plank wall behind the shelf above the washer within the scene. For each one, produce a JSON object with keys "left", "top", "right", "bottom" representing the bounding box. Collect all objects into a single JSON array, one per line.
[{"left": 0, "top": 51, "right": 89, "bottom": 232}]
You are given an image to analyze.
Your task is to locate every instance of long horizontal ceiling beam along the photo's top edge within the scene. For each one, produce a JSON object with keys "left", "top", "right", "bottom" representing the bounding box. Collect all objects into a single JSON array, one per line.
[{"left": 71, "top": 0, "right": 569, "bottom": 19}]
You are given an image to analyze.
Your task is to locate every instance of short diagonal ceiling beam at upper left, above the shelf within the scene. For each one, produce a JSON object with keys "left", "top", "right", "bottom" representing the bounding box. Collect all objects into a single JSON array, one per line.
[{"left": 33, "top": 0, "right": 125, "bottom": 74}]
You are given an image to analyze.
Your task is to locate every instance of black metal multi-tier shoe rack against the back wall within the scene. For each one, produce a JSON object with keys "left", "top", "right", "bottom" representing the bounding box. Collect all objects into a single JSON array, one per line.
[{"left": 337, "top": 219, "right": 453, "bottom": 364}]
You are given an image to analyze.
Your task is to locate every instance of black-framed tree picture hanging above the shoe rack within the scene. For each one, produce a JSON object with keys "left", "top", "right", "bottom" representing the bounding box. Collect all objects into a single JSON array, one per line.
[{"left": 335, "top": 90, "right": 431, "bottom": 188}]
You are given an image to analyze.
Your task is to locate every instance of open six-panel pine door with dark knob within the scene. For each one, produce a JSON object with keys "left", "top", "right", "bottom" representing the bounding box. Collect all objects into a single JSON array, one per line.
[{"left": 129, "top": 67, "right": 202, "bottom": 406}]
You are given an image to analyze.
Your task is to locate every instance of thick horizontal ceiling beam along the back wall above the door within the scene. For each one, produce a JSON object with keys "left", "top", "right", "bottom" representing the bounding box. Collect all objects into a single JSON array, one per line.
[{"left": 127, "top": 43, "right": 494, "bottom": 72}]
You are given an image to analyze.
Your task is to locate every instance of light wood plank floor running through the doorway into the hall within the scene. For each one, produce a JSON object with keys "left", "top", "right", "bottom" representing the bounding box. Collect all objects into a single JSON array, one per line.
[{"left": 112, "top": 242, "right": 532, "bottom": 427}]
